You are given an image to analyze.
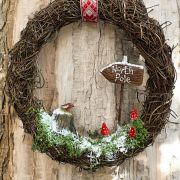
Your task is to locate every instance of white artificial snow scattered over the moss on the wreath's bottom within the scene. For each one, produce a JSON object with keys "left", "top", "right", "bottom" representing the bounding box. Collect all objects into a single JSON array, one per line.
[{"left": 40, "top": 109, "right": 128, "bottom": 163}]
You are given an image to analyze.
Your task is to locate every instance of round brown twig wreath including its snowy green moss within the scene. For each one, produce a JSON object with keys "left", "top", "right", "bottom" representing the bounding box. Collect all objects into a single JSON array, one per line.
[{"left": 6, "top": 0, "right": 175, "bottom": 170}]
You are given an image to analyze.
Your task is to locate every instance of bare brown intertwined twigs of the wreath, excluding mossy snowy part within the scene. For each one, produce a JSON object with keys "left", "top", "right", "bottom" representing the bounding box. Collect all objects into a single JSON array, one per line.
[{"left": 6, "top": 0, "right": 175, "bottom": 169}]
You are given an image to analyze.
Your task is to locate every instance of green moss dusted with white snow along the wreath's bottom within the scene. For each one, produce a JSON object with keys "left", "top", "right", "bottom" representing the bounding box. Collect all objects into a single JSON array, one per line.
[{"left": 28, "top": 109, "right": 148, "bottom": 166}]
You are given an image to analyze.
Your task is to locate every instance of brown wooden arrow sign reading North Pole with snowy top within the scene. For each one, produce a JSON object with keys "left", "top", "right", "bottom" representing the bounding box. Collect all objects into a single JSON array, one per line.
[{"left": 101, "top": 62, "right": 144, "bottom": 86}]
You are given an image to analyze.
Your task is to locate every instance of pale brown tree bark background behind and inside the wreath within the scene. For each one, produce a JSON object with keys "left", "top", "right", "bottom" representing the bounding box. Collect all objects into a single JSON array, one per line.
[{"left": 0, "top": 0, "right": 180, "bottom": 180}]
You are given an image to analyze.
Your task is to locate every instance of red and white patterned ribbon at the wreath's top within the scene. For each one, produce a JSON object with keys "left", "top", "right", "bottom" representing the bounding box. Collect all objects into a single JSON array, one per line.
[{"left": 80, "top": 0, "right": 98, "bottom": 22}]
